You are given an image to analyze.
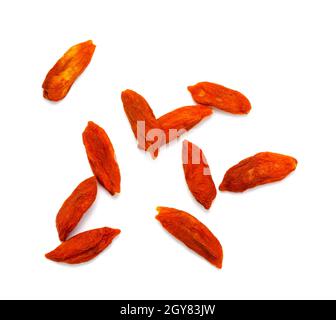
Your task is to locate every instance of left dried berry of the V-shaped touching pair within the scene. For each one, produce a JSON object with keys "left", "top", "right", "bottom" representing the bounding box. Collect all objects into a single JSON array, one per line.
[{"left": 121, "top": 90, "right": 163, "bottom": 158}]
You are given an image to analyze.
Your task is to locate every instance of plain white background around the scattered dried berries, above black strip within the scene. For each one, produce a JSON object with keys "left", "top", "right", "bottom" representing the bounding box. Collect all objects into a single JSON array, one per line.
[{"left": 0, "top": 0, "right": 336, "bottom": 299}]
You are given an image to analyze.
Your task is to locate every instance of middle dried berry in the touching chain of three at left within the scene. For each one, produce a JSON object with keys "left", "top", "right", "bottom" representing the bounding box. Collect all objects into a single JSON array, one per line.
[{"left": 56, "top": 177, "right": 97, "bottom": 241}]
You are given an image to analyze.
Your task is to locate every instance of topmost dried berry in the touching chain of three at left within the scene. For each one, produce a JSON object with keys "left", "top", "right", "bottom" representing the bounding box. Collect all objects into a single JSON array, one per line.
[{"left": 83, "top": 121, "right": 120, "bottom": 195}]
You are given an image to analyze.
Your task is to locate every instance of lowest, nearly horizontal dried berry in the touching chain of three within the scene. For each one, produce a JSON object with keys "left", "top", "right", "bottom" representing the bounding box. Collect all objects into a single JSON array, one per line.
[{"left": 46, "top": 227, "right": 120, "bottom": 264}]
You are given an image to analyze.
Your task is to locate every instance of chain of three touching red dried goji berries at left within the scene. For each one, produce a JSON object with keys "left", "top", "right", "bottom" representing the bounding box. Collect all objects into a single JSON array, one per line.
[{"left": 46, "top": 121, "right": 120, "bottom": 264}]
